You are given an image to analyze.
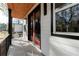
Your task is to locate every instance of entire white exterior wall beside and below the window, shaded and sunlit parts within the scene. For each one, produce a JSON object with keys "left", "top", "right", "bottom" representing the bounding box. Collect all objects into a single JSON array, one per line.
[{"left": 27, "top": 4, "right": 79, "bottom": 56}]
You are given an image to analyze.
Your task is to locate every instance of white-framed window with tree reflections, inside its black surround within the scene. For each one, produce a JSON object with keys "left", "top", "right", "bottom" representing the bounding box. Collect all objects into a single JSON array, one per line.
[{"left": 53, "top": 3, "right": 79, "bottom": 36}]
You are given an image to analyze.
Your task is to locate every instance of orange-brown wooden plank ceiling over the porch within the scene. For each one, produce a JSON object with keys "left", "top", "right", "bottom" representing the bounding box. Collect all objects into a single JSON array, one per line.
[{"left": 8, "top": 3, "right": 35, "bottom": 19}]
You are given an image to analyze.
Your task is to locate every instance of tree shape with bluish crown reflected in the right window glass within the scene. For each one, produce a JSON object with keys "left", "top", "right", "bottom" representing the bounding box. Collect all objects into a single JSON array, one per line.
[{"left": 58, "top": 7, "right": 74, "bottom": 32}]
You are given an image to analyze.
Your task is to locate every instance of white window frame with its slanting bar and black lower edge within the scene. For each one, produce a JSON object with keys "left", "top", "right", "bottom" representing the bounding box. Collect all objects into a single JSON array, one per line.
[{"left": 51, "top": 3, "right": 79, "bottom": 39}]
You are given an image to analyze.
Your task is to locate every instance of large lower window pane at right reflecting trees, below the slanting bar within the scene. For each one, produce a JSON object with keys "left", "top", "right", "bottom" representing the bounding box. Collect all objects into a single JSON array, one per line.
[{"left": 56, "top": 4, "right": 79, "bottom": 32}]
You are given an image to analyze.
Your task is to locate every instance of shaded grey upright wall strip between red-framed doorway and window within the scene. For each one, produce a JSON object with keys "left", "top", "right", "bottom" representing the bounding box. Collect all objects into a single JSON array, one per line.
[{"left": 41, "top": 4, "right": 51, "bottom": 55}]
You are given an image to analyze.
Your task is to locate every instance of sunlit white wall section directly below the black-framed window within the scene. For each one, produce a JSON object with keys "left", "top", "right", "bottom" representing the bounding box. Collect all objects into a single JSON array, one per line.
[{"left": 50, "top": 36, "right": 79, "bottom": 56}]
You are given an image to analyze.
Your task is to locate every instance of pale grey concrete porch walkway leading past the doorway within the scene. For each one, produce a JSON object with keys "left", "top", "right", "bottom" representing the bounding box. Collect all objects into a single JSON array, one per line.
[{"left": 8, "top": 33, "right": 42, "bottom": 56}]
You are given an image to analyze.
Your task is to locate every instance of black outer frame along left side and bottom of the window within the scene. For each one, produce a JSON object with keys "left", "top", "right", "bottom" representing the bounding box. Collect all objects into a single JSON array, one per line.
[{"left": 51, "top": 3, "right": 79, "bottom": 40}]
